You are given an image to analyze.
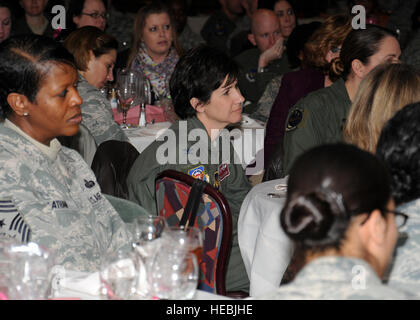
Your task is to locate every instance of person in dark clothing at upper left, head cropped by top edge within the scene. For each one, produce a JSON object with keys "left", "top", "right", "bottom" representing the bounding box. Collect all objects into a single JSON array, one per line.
[{"left": 13, "top": 0, "right": 54, "bottom": 37}]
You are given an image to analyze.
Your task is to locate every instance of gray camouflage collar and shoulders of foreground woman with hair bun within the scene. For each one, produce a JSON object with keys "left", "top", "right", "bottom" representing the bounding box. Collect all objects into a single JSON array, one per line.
[{"left": 257, "top": 256, "right": 418, "bottom": 300}]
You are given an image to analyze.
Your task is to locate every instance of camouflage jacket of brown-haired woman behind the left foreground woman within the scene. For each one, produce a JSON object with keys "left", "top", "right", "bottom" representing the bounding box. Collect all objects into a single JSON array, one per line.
[{"left": 77, "top": 74, "right": 129, "bottom": 146}]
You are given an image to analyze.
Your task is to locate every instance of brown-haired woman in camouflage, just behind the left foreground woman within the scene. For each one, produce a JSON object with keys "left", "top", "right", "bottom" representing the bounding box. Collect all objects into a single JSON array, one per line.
[{"left": 64, "top": 26, "right": 128, "bottom": 146}]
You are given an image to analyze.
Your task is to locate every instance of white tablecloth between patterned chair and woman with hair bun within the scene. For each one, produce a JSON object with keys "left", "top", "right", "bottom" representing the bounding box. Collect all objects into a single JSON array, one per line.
[{"left": 238, "top": 179, "right": 293, "bottom": 296}]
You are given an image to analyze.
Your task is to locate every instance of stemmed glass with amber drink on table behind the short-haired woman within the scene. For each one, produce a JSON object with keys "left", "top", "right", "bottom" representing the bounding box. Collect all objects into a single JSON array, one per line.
[{"left": 116, "top": 69, "right": 140, "bottom": 129}]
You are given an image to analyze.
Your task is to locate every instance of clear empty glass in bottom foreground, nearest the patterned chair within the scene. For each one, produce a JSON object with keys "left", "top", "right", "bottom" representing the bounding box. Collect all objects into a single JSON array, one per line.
[{"left": 150, "top": 248, "right": 199, "bottom": 299}]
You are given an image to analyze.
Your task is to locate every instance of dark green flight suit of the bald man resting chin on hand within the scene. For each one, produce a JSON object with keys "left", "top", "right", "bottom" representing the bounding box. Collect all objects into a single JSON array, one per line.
[{"left": 234, "top": 48, "right": 292, "bottom": 113}]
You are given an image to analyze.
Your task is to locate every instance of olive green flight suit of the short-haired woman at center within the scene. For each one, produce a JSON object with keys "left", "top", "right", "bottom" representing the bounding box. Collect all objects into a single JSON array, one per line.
[{"left": 127, "top": 117, "right": 252, "bottom": 292}]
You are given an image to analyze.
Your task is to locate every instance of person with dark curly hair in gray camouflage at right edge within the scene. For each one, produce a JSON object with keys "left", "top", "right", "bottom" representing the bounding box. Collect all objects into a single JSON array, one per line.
[{"left": 376, "top": 102, "right": 420, "bottom": 292}]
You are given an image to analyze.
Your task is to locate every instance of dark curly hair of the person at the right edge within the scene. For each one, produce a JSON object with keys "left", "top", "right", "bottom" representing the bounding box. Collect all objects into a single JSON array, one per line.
[{"left": 376, "top": 102, "right": 420, "bottom": 205}]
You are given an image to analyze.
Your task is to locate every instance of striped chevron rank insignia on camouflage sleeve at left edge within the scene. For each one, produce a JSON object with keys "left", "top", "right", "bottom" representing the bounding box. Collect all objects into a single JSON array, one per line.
[{"left": 0, "top": 200, "right": 31, "bottom": 243}]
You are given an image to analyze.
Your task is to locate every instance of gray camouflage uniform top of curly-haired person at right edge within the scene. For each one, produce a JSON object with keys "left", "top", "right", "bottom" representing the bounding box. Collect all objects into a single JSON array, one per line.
[{"left": 388, "top": 199, "right": 420, "bottom": 292}]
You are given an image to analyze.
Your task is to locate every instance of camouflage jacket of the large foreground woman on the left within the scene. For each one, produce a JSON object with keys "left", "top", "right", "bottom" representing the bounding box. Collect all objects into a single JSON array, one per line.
[{"left": 0, "top": 123, "right": 130, "bottom": 272}]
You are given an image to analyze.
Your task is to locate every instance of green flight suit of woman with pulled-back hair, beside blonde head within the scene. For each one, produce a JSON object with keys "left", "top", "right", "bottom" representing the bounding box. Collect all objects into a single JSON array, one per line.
[{"left": 283, "top": 79, "right": 351, "bottom": 175}]
